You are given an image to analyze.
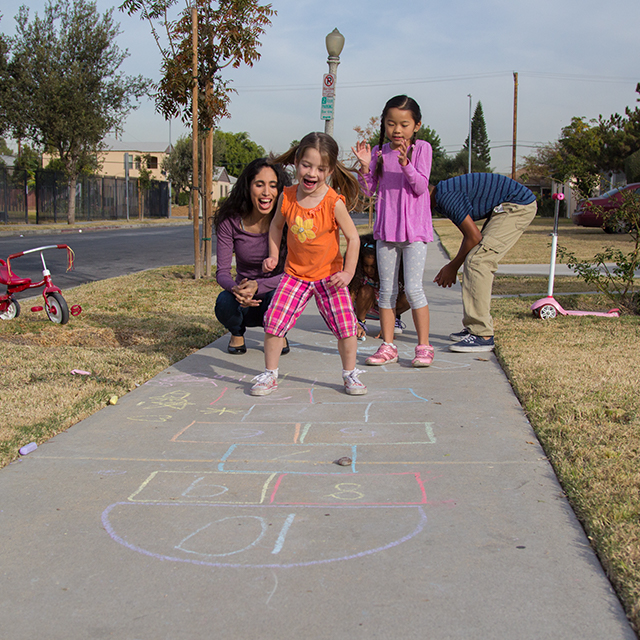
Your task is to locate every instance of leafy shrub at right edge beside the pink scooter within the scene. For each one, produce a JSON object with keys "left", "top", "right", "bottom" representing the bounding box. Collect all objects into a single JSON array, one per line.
[{"left": 558, "top": 190, "right": 640, "bottom": 315}]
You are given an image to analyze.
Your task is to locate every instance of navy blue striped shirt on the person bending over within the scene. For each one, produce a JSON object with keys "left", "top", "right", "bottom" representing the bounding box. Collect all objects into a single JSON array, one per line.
[{"left": 436, "top": 173, "right": 536, "bottom": 227}]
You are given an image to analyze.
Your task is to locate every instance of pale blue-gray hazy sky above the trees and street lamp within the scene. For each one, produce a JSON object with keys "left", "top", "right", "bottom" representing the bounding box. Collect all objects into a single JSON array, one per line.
[{"left": 0, "top": 0, "right": 640, "bottom": 174}]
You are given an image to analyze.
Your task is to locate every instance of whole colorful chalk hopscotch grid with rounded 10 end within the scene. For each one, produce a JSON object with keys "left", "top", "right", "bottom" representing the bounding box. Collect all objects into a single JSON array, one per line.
[{"left": 102, "top": 370, "right": 436, "bottom": 568}]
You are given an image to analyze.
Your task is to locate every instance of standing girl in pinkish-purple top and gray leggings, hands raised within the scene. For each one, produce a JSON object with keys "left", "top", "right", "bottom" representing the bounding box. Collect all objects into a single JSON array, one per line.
[{"left": 353, "top": 95, "right": 433, "bottom": 367}]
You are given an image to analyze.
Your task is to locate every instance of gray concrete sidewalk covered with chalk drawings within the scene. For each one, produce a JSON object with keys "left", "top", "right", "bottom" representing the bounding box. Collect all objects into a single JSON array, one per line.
[{"left": 0, "top": 245, "right": 635, "bottom": 640}]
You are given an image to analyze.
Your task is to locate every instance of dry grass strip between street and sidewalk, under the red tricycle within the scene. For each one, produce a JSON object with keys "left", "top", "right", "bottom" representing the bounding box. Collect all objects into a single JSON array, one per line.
[{"left": 0, "top": 267, "right": 224, "bottom": 465}]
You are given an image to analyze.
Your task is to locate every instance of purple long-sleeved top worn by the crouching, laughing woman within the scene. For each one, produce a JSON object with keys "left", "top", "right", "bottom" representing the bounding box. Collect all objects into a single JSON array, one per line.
[{"left": 216, "top": 217, "right": 283, "bottom": 298}]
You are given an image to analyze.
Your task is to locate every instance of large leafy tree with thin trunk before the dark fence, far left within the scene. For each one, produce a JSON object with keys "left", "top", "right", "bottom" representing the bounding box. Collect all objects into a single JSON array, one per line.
[{"left": 5, "top": 0, "right": 148, "bottom": 224}]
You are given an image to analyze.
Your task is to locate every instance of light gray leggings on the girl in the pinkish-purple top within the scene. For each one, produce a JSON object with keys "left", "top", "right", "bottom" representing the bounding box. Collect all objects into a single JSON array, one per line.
[{"left": 376, "top": 240, "right": 428, "bottom": 309}]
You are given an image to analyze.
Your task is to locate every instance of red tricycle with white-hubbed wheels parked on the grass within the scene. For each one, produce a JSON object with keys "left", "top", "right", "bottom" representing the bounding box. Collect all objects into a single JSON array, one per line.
[{"left": 0, "top": 244, "right": 80, "bottom": 324}]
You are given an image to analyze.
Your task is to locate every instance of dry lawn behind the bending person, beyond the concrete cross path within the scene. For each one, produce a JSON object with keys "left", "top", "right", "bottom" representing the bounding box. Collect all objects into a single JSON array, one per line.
[{"left": 433, "top": 217, "right": 633, "bottom": 264}]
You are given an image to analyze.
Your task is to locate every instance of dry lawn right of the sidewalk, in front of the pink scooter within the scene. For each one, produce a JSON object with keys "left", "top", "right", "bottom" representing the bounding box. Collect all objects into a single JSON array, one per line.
[{"left": 492, "top": 295, "right": 640, "bottom": 630}]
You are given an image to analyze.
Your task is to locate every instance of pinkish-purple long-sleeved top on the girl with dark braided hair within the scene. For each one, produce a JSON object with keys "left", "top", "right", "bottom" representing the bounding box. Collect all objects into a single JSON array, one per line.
[{"left": 360, "top": 140, "right": 433, "bottom": 242}]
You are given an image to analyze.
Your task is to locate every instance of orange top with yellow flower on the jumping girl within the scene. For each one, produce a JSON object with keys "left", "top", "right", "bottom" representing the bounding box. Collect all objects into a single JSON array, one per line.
[{"left": 281, "top": 185, "right": 345, "bottom": 282}]
